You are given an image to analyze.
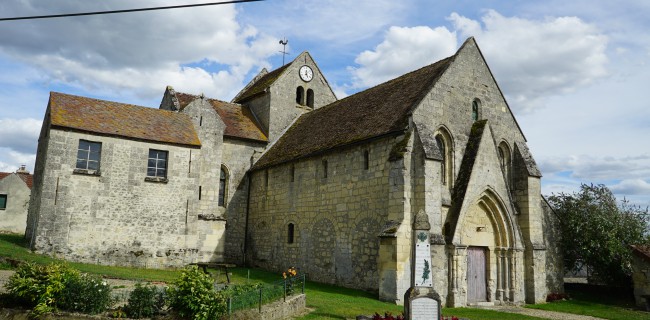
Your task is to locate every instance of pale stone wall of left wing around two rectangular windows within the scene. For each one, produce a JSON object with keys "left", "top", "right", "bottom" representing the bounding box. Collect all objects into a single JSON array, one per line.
[{"left": 30, "top": 129, "right": 200, "bottom": 267}]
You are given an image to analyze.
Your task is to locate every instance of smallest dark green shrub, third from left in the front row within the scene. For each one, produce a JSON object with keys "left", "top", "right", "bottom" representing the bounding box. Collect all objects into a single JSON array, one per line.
[{"left": 124, "top": 283, "right": 165, "bottom": 319}]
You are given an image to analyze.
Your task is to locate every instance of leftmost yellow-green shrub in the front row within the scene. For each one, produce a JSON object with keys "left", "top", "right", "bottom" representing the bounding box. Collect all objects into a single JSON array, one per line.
[{"left": 5, "top": 263, "right": 79, "bottom": 317}]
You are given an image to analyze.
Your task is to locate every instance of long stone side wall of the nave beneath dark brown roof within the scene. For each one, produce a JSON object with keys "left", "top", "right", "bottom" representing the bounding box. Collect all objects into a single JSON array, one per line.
[{"left": 247, "top": 138, "right": 395, "bottom": 290}]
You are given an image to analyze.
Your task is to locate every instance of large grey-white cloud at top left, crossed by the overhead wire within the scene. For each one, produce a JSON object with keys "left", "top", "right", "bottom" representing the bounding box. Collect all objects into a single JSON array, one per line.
[{"left": 0, "top": 0, "right": 277, "bottom": 99}]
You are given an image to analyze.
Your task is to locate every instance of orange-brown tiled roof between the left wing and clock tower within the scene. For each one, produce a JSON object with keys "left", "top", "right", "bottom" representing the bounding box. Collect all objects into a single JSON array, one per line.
[{"left": 176, "top": 92, "right": 268, "bottom": 142}]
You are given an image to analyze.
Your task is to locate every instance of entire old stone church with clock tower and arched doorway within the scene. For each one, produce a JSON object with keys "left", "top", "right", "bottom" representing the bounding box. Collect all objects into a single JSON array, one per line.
[{"left": 26, "top": 38, "right": 562, "bottom": 306}]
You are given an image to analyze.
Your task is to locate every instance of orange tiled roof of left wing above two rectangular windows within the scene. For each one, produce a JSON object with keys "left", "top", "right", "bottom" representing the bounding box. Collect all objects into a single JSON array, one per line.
[{"left": 49, "top": 92, "right": 201, "bottom": 146}]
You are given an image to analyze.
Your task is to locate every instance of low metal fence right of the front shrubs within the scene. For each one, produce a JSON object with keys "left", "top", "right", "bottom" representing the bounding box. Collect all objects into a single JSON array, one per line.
[{"left": 228, "top": 274, "right": 306, "bottom": 314}]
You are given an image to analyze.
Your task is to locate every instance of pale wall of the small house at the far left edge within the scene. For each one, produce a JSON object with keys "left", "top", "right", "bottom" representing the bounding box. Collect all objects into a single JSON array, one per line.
[{"left": 0, "top": 174, "right": 31, "bottom": 234}]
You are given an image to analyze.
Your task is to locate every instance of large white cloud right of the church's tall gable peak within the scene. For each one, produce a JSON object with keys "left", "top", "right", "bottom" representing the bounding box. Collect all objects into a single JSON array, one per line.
[{"left": 448, "top": 10, "right": 608, "bottom": 112}]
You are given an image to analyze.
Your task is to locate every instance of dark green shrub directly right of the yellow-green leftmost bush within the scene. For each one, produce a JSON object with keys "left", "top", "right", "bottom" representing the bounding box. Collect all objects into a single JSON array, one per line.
[{"left": 56, "top": 274, "right": 114, "bottom": 314}]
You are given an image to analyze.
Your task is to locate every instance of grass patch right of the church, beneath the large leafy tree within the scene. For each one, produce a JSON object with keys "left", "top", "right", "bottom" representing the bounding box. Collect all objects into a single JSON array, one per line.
[{"left": 527, "top": 285, "right": 650, "bottom": 320}]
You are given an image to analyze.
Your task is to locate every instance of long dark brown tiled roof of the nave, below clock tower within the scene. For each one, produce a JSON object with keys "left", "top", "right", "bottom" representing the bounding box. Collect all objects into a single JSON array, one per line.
[{"left": 253, "top": 56, "right": 453, "bottom": 170}]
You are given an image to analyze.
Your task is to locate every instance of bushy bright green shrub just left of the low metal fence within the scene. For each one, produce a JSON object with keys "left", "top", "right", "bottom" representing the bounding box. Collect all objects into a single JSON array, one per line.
[{"left": 167, "top": 266, "right": 226, "bottom": 320}]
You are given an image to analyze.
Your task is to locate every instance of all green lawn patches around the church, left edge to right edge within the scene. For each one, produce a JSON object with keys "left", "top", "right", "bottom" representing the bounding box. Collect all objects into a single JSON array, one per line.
[{"left": 0, "top": 234, "right": 650, "bottom": 320}]
